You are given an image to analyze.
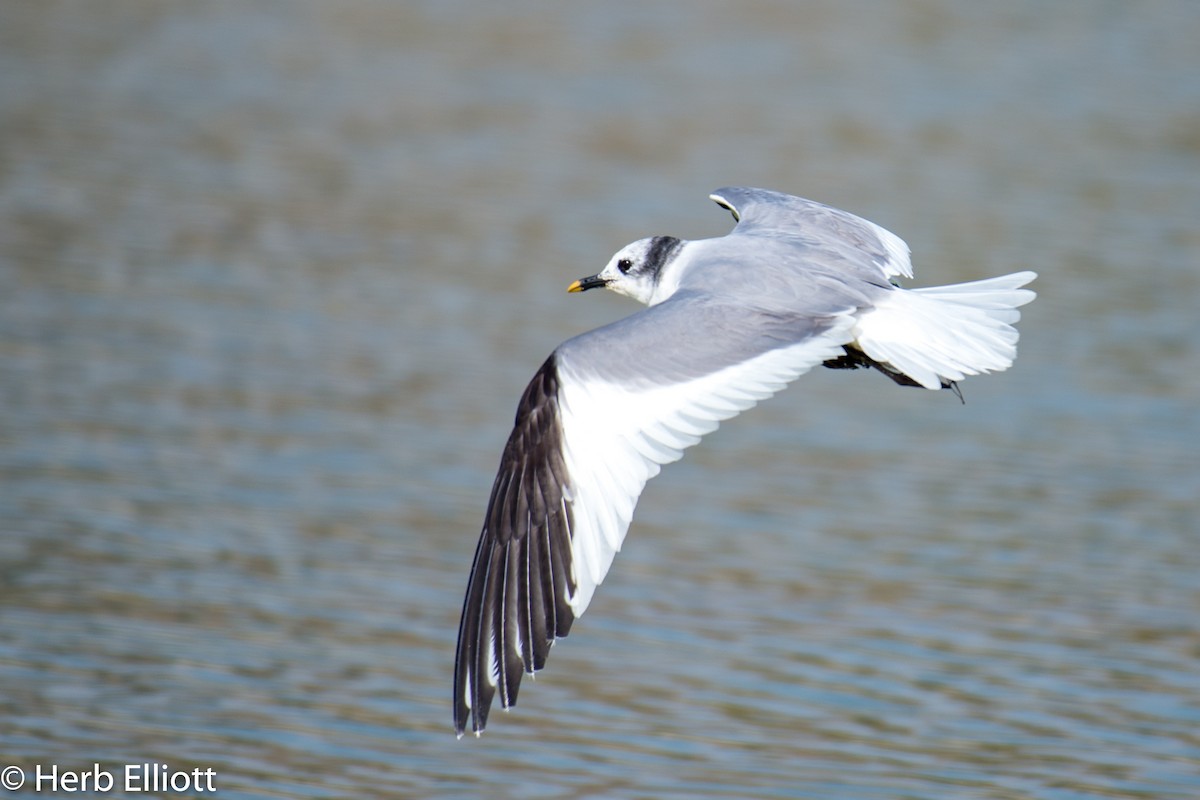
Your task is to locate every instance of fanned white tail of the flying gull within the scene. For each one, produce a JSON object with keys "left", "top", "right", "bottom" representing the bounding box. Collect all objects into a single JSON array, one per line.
[{"left": 853, "top": 272, "right": 1037, "bottom": 389}]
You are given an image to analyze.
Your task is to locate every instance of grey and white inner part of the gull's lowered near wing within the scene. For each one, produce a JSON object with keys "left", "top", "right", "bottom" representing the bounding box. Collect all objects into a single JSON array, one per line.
[{"left": 558, "top": 302, "right": 854, "bottom": 616}]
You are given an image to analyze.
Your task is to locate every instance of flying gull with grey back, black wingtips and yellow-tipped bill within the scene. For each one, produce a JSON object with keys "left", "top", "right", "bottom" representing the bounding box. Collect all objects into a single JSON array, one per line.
[{"left": 454, "top": 187, "right": 1037, "bottom": 738}]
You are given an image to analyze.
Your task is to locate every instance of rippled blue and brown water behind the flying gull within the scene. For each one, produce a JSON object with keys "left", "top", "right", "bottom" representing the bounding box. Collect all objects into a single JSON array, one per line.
[{"left": 0, "top": 0, "right": 1200, "bottom": 800}]
